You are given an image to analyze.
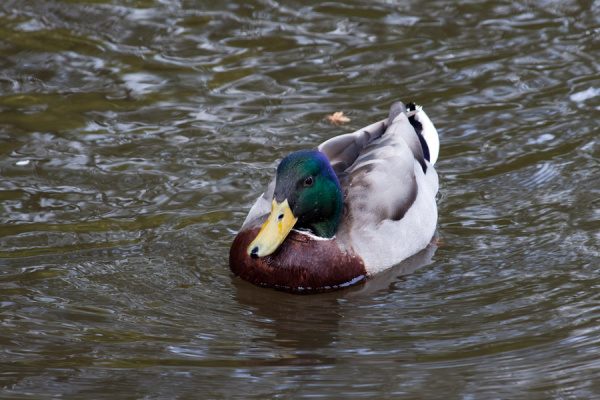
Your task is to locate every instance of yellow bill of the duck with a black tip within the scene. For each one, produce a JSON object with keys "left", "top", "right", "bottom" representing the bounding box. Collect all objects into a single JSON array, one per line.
[{"left": 247, "top": 199, "right": 298, "bottom": 258}]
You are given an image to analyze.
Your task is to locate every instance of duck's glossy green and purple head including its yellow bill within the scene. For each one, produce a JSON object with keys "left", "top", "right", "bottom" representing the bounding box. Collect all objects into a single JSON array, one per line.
[{"left": 248, "top": 150, "right": 344, "bottom": 258}]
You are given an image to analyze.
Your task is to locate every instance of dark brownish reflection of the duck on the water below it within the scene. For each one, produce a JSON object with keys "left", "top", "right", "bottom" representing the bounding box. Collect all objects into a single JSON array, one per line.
[{"left": 234, "top": 242, "right": 437, "bottom": 354}]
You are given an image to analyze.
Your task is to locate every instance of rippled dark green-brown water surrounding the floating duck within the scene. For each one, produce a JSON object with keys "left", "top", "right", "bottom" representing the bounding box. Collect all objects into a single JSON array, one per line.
[{"left": 0, "top": 0, "right": 600, "bottom": 399}]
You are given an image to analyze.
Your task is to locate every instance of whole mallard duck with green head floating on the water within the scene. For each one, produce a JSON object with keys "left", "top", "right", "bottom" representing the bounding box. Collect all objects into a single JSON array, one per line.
[{"left": 229, "top": 102, "right": 439, "bottom": 291}]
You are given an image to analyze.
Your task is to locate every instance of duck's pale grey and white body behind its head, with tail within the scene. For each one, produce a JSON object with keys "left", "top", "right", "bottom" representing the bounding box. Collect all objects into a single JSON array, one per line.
[{"left": 318, "top": 103, "right": 439, "bottom": 273}]
